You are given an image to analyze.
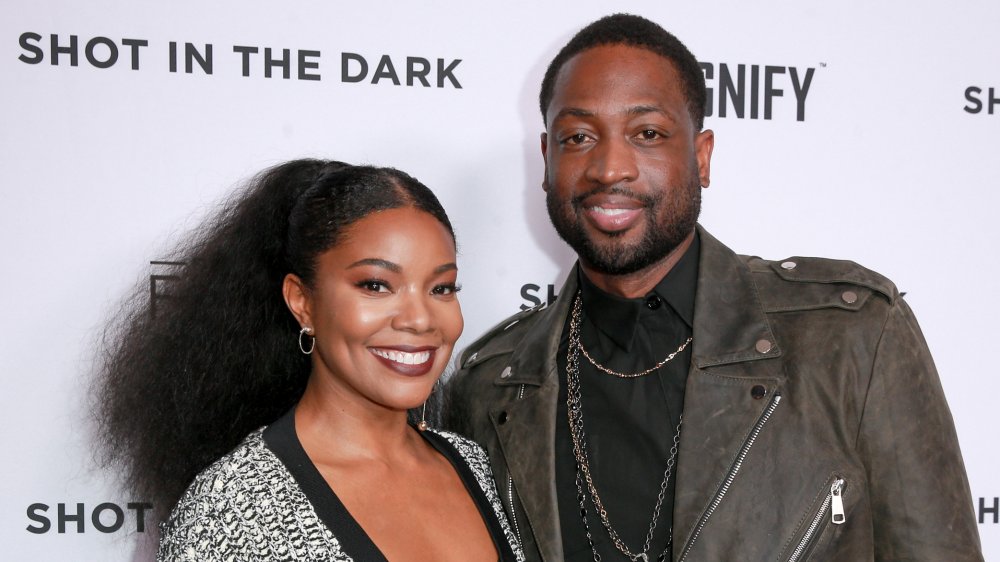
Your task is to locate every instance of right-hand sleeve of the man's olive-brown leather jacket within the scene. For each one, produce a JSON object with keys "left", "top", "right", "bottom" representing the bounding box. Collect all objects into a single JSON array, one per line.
[{"left": 858, "top": 298, "right": 983, "bottom": 562}]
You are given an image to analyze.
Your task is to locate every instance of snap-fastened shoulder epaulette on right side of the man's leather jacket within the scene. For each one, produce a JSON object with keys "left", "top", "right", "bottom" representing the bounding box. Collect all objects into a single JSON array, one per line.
[{"left": 740, "top": 256, "right": 900, "bottom": 312}]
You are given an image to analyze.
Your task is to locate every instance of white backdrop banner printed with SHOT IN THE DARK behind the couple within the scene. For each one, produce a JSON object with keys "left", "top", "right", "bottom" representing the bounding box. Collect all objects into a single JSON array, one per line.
[{"left": 0, "top": 0, "right": 1000, "bottom": 561}]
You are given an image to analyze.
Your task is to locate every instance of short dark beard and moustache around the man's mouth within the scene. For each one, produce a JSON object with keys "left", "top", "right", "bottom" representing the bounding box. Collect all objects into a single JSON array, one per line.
[{"left": 545, "top": 175, "right": 701, "bottom": 275}]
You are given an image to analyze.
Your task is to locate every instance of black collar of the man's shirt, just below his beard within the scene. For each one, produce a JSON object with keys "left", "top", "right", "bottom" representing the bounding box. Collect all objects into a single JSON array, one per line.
[{"left": 579, "top": 233, "right": 701, "bottom": 351}]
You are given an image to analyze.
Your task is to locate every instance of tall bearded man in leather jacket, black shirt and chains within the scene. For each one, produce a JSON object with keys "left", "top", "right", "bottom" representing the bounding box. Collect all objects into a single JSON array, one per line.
[{"left": 445, "top": 15, "right": 982, "bottom": 562}]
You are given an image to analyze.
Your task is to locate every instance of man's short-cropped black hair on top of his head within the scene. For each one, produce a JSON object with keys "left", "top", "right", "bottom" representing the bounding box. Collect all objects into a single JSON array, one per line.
[{"left": 538, "top": 14, "right": 706, "bottom": 131}]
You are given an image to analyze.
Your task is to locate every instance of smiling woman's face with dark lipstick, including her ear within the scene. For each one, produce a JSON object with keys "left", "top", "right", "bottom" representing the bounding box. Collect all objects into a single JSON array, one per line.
[{"left": 286, "top": 208, "right": 463, "bottom": 416}]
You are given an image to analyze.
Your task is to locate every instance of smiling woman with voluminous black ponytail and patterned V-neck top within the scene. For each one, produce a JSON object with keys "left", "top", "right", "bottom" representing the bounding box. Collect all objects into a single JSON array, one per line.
[{"left": 99, "top": 160, "right": 523, "bottom": 561}]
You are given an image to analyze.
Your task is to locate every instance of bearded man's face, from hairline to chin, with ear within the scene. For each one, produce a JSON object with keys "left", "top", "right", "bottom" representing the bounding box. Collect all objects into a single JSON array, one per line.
[{"left": 542, "top": 45, "right": 714, "bottom": 275}]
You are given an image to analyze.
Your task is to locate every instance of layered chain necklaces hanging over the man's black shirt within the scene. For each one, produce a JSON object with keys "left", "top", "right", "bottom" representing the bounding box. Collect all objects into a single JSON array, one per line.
[{"left": 566, "top": 293, "right": 692, "bottom": 562}]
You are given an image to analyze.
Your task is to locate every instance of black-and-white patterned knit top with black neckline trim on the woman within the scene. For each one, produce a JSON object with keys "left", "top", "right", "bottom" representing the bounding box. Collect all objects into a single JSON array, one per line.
[{"left": 156, "top": 406, "right": 524, "bottom": 562}]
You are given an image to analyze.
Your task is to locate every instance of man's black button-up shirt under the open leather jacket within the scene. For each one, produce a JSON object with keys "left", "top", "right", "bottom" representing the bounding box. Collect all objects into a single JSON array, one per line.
[{"left": 555, "top": 236, "right": 700, "bottom": 562}]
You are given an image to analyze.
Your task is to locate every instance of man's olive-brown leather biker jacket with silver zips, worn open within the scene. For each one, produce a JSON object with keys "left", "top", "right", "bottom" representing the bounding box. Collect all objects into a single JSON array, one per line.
[{"left": 444, "top": 227, "right": 982, "bottom": 562}]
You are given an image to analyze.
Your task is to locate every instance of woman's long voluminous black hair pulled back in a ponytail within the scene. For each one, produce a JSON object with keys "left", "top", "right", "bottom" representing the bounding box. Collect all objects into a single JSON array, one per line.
[{"left": 92, "top": 159, "right": 454, "bottom": 518}]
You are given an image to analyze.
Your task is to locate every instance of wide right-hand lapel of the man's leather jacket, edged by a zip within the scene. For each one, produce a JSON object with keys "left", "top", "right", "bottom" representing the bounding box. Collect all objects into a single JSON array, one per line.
[{"left": 674, "top": 226, "right": 785, "bottom": 559}]
